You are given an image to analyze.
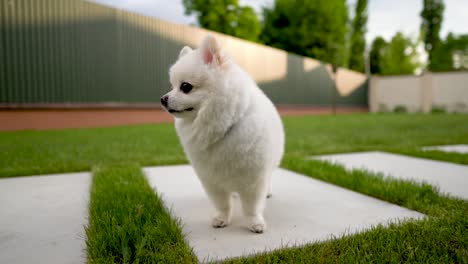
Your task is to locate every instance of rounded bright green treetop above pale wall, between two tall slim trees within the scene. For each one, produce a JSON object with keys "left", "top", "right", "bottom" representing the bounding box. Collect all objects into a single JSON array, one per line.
[{"left": 370, "top": 32, "right": 421, "bottom": 75}]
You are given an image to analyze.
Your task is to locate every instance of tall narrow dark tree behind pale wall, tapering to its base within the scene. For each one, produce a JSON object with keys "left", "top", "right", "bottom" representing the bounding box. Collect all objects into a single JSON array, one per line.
[{"left": 421, "top": 0, "right": 444, "bottom": 71}]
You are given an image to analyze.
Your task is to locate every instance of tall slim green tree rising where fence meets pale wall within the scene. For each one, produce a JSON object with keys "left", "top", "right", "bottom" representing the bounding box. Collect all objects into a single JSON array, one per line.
[{"left": 349, "top": 0, "right": 367, "bottom": 72}]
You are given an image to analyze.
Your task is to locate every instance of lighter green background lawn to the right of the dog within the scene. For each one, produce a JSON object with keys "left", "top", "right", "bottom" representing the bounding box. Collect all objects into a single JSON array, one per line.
[{"left": 284, "top": 114, "right": 468, "bottom": 160}]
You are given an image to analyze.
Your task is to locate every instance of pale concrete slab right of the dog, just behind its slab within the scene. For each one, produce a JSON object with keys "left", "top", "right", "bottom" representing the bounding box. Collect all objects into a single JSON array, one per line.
[{"left": 313, "top": 151, "right": 468, "bottom": 199}]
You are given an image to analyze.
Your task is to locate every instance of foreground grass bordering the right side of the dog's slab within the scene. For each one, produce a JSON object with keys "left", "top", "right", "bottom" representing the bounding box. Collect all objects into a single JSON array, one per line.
[{"left": 223, "top": 157, "right": 468, "bottom": 263}]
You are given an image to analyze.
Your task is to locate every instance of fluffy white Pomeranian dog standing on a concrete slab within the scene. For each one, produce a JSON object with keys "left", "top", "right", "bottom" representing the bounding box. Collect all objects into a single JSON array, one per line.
[{"left": 161, "top": 36, "right": 284, "bottom": 233}]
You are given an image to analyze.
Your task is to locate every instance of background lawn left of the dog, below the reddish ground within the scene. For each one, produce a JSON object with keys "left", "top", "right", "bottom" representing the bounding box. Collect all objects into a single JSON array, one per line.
[{"left": 0, "top": 124, "right": 186, "bottom": 177}]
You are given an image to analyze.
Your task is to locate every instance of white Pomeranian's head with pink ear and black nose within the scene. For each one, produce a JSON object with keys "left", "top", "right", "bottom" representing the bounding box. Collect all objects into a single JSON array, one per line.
[{"left": 161, "top": 36, "right": 227, "bottom": 118}]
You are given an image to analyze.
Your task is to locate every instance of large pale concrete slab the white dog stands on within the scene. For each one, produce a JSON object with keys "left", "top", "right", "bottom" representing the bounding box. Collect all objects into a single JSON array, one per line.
[{"left": 144, "top": 166, "right": 424, "bottom": 261}]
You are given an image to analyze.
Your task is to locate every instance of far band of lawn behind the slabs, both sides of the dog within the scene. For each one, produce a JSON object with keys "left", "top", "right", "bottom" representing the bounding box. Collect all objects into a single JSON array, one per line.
[{"left": 0, "top": 114, "right": 468, "bottom": 177}]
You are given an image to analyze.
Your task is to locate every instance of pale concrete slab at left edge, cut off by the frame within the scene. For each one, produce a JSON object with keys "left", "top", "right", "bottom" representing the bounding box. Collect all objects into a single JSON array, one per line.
[{"left": 0, "top": 173, "right": 91, "bottom": 264}]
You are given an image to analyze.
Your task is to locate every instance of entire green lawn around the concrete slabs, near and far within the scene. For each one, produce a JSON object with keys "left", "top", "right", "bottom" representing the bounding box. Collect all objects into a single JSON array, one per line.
[{"left": 0, "top": 114, "right": 468, "bottom": 263}]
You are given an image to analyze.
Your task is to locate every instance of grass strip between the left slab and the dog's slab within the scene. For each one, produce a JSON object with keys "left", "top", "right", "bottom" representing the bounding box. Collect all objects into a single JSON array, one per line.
[{"left": 86, "top": 165, "right": 197, "bottom": 263}]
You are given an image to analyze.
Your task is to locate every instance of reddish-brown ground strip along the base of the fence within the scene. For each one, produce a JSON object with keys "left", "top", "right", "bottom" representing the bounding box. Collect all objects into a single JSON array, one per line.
[{"left": 0, "top": 107, "right": 368, "bottom": 131}]
